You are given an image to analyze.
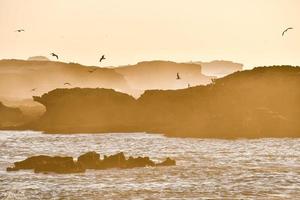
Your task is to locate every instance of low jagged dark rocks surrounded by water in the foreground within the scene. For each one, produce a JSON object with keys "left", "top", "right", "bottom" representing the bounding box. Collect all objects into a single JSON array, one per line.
[{"left": 6, "top": 151, "right": 176, "bottom": 174}]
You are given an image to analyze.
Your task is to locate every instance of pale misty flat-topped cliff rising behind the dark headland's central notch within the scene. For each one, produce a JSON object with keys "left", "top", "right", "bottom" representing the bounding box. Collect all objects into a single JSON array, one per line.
[{"left": 115, "top": 61, "right": 212, "bottom": 90}]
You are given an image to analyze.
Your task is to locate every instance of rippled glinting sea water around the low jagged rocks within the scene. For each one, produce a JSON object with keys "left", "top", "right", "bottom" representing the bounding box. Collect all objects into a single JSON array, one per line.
[{"left": 0, "top": 131, "right": 300, "bottom": 200}]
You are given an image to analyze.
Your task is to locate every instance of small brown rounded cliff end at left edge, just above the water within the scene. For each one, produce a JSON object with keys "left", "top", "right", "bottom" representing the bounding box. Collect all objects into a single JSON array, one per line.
[{"left": 0, "top": 102, "right": 23, "bottom": 128}]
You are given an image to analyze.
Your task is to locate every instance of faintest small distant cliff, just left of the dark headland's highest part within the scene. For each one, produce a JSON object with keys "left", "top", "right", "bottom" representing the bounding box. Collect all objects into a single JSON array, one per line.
[{"left": 194, "top": 60, "right": 243, "bottom": 78}]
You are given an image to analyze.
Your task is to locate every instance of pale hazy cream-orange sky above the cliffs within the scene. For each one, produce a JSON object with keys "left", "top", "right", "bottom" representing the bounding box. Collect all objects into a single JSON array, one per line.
[{"left": 0, "top": 0, "right": 300, "bottom": 68}]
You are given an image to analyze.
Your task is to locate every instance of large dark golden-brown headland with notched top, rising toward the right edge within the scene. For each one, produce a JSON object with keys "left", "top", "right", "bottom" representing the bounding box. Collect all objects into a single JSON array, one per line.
[{"left": 27, "top": 66, "right": 300, "bottom": 138}]
